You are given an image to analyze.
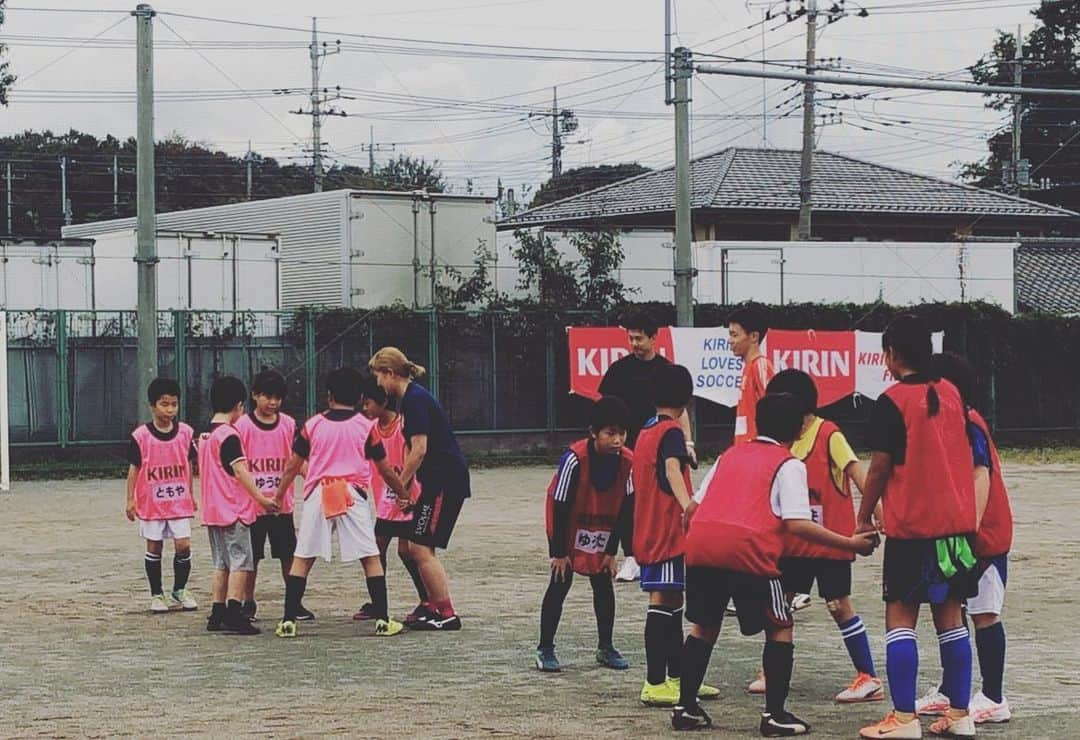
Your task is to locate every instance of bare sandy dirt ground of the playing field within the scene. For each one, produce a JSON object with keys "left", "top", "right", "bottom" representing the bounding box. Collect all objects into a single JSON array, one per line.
[{"left": 0, "top": 466, "right": 1080, "bottom": 739}]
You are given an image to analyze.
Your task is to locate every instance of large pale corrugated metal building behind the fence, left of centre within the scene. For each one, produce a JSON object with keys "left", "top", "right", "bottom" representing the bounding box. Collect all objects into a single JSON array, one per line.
[{"left": 63, "top": 190, "right": 495, "bottom": 310}]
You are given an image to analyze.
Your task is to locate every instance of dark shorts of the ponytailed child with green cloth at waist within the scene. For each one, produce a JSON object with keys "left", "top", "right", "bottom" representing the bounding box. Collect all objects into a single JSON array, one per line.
[{"left": 881, "top": 537, "right": 980, "bottom": 604}]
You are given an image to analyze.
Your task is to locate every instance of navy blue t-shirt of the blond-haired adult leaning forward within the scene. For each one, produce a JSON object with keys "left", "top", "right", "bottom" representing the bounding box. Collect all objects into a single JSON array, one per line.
[{"left": 399, "top": 382, "right": 471, "bottom": 498}]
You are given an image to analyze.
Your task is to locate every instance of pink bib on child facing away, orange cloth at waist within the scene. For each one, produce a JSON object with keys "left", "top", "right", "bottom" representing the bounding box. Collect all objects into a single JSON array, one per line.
[{"left": 303, "top": 414, "right": 375, "bottom": 500}]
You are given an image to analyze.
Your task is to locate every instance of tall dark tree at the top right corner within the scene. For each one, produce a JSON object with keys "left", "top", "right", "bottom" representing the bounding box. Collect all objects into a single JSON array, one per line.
[{"left": 960, "top": 2, "right": 1080, "bottom": 210}]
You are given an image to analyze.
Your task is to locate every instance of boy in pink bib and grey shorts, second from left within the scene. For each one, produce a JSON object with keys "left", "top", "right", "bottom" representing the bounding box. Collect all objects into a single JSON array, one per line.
[{"left": 199, "top": 376, "right": 279, "bottom": 635}]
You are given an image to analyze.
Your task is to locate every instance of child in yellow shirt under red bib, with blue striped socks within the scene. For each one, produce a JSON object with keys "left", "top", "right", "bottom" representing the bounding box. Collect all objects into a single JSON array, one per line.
[{"left": 750, "top": 369, "right": 885, "bottom": 704}]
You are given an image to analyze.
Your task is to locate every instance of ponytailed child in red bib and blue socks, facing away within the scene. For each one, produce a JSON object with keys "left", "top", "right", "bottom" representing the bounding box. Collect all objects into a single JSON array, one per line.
[{"left": 856, "top": 315, "right": 978, "bottom": 738}]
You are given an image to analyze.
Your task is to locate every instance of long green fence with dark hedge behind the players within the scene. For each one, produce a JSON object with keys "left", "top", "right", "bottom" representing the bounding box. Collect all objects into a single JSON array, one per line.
[{"left": 6, "top": 307, "right": 1080, "bottom": 447}]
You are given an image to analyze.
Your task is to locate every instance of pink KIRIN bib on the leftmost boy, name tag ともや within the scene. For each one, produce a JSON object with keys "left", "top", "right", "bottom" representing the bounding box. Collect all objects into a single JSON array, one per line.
[{"left": 132, "top": 422, "right": 194, "bottom": 522}]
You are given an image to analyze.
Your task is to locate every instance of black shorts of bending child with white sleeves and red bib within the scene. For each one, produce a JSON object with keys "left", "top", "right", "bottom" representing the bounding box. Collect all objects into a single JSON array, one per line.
[{"left": 686, "top": 565, "right": 792, "bottom": 635}]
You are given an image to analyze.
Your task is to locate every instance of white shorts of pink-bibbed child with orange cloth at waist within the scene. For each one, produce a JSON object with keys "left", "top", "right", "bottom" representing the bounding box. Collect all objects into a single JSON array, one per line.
[{"left": 293, "top": 486, "right": 379, "bottom": 563}]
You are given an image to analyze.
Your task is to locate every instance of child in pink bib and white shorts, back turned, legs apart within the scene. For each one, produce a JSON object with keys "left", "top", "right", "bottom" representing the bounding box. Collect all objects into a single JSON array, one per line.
[{"left": 274, "top": 367, "right": 406, "bottom": 637}]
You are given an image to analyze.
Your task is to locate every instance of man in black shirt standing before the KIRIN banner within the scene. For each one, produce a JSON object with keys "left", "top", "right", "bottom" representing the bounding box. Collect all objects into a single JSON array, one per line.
[{"left": 599, "top": 315, "right": 697, "bottom": 581}]
